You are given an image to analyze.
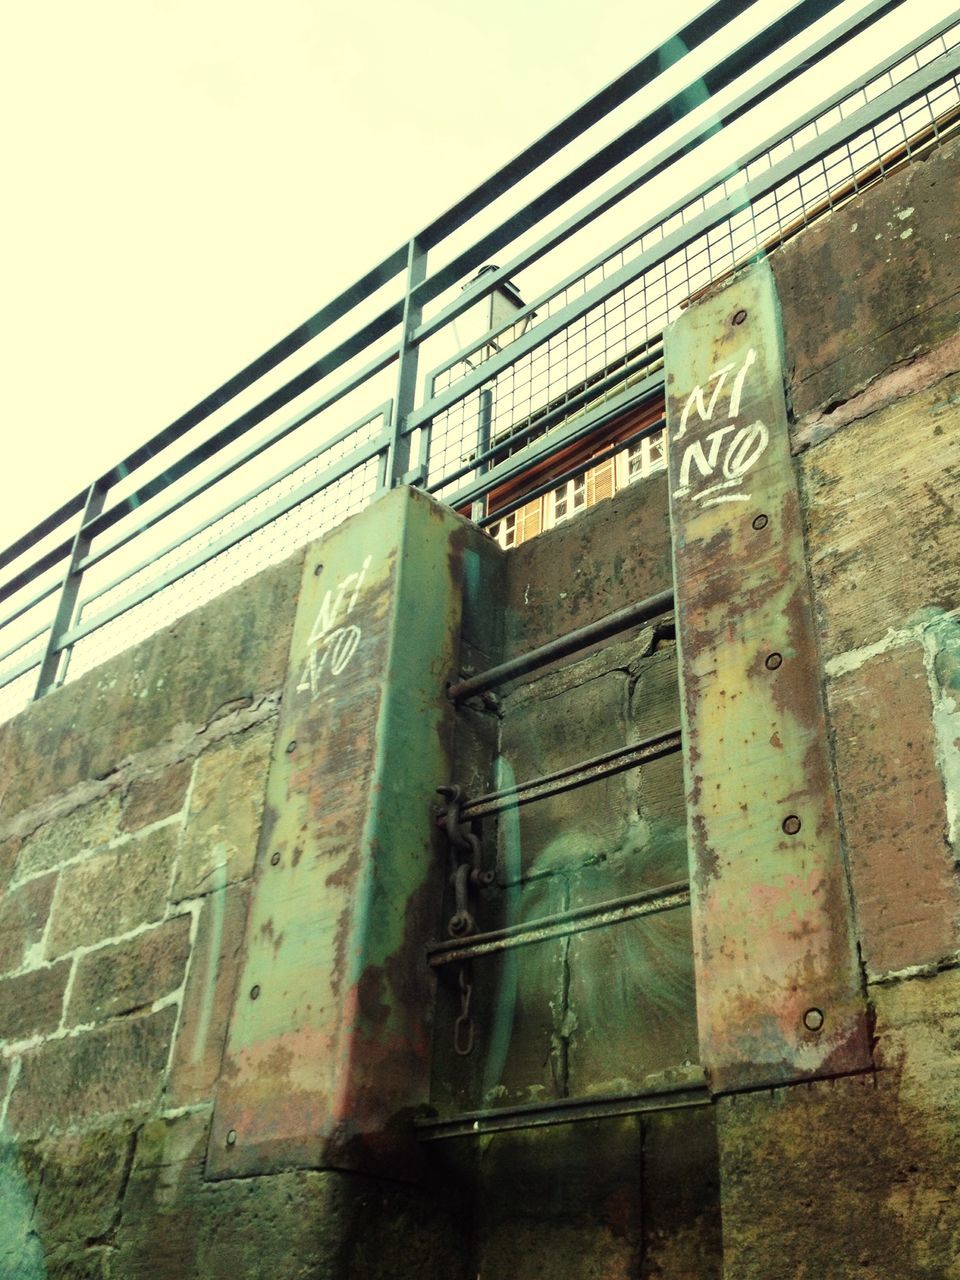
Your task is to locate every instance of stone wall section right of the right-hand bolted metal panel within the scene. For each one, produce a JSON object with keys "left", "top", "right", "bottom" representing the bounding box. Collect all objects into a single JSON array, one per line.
[{"left": 717, "top": 135, "right": 960, "bottom": 1280}]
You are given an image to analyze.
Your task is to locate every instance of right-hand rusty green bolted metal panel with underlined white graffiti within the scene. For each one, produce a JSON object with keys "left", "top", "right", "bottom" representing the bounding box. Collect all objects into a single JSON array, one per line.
[{"left": 666, "top": 262, "right": 870, "bottom": 1092}]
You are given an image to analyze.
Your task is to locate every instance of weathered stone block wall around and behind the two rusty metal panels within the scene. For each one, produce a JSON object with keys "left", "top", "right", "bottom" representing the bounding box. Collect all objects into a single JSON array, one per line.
[{"left": 0, "top": 132, "right": 960, "bottom": 1280}]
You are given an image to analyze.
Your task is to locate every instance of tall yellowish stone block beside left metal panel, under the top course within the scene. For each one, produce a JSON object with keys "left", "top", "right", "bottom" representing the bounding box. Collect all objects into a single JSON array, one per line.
[{"left": 173, "top": 722, "right": 276, "bottom": 901}]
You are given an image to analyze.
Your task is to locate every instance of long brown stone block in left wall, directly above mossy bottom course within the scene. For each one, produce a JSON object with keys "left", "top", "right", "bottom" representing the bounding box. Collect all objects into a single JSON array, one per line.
[{"left": 6, "top": 1009, "right": 177, "bottom": 1137}]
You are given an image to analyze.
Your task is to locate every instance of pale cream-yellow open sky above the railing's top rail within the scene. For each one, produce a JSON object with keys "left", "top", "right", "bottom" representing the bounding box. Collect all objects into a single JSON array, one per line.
[{"left": 0, "top": 0, "right": 950, "bottom": 547}]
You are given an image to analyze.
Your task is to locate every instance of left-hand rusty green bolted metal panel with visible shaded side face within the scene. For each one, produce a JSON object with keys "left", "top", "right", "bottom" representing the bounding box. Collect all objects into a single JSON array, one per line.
[{"left": 207, "top": 489, "right": 471, "bottom": 1178}]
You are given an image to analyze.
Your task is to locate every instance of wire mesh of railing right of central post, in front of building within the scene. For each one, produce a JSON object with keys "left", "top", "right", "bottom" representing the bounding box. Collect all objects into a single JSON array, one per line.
[{"left": 428, "top": 24, "right": 960, "bottom": 502}]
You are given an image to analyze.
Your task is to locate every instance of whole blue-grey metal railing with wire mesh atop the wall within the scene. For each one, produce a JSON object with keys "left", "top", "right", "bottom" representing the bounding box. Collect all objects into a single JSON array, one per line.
[{"left": 0, "top": 0, "right": 960, "bottom": 718}]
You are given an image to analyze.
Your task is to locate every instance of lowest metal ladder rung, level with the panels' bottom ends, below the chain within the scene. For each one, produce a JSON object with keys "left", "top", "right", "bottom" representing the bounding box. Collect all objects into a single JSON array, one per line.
[{"left": 413, "top": 1080, "right": 710, "bottom": 1142}]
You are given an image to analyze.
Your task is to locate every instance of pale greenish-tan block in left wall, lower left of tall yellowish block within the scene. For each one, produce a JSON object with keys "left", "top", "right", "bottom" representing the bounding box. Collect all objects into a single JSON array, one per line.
[{"left": 47, "top": 827, "right": 177, "bottom": 957}]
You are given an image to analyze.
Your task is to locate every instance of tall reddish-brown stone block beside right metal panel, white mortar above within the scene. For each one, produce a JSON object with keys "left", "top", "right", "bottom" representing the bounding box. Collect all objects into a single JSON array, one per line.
[{"left": 829, "top": 645, "right": 960, "bottom": 974}]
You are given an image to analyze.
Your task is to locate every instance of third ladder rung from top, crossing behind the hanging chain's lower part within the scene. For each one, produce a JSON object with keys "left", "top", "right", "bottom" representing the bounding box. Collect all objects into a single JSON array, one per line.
[{"left": 426, "top": 881, "right": 690, "bottom": 969}]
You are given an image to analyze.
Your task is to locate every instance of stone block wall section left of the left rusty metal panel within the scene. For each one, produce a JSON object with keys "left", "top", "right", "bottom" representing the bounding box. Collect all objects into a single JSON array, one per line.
[{"left": 0, "top": 556, "right": 302, "bottom": 1277}]
